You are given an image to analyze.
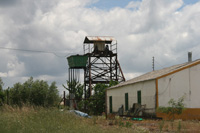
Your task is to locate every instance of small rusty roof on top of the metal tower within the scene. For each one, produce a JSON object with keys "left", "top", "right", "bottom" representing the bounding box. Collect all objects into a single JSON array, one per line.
[{"left": 84, "top": 36, "right": 115, "bottom": 44}]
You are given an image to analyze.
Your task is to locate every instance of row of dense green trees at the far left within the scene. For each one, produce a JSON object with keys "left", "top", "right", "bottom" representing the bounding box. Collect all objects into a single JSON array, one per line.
[{"left": 0, "top": 77, "right": 60, "bottom": 107}]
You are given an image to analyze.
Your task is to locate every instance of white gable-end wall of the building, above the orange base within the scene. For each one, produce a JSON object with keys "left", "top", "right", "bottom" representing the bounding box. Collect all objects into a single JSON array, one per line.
[{"left": 158, "top": 65, "right": 200, "bottom": 108}]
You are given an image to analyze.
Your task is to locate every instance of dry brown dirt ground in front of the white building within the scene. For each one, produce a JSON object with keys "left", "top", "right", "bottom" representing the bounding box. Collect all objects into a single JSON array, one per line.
[{"left": 93, "top": 117, "right": 200, "bottom": 133}]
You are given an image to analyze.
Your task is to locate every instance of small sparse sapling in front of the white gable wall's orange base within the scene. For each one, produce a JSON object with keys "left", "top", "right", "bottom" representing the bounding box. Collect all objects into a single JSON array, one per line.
[{"left": 157, "top": 96, "right": 185, "bottom": 120}]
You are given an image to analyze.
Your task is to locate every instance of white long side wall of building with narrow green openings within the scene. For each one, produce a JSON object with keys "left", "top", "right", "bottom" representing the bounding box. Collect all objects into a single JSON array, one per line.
[{"left": 107, "top": 80, "right": 156, "bottom": 113}]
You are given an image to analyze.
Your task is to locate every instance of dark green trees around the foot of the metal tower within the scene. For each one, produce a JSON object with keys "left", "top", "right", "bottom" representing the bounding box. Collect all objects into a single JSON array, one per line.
[{"left": 63, "top": 80, "right": 118, "bottom": 115}]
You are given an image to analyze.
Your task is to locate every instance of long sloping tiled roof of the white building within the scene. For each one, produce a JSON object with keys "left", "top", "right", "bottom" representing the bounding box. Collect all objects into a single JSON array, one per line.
[{"left": 108, "top": 59, "right": 200, "bottom": 89}]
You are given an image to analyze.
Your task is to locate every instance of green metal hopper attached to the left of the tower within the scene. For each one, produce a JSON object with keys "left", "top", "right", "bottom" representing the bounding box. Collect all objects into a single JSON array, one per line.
[{"left": 67, "top": 55, "right": 88, "bottom": 68}]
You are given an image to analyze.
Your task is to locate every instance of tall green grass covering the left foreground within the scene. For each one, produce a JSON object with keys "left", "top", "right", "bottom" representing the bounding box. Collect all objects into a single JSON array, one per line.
[{"left": 0, "top": 106, "right": 136, "bottom": 133}]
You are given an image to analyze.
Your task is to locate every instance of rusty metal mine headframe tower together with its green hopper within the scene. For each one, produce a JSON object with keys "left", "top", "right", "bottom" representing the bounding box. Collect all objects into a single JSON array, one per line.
[{"left": 67, "top": 36, "right": 125, "bottom": 98}]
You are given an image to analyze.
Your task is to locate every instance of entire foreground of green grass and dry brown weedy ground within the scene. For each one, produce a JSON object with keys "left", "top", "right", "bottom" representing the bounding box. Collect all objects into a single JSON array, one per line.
[{"left": 0, "top": 106, "right": 200, "bottom": 133}]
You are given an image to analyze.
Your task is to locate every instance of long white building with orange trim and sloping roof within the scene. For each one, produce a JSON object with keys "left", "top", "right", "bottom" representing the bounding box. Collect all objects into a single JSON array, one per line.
[{"left": 106, "top": 60, "right": 200, "bottom": 119}]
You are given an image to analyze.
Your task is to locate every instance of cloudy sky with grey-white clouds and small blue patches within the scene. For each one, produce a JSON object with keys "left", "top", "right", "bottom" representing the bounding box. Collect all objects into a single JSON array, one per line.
[{"left": 0, "top": 0, "right": 200, "bottom": 93}]
